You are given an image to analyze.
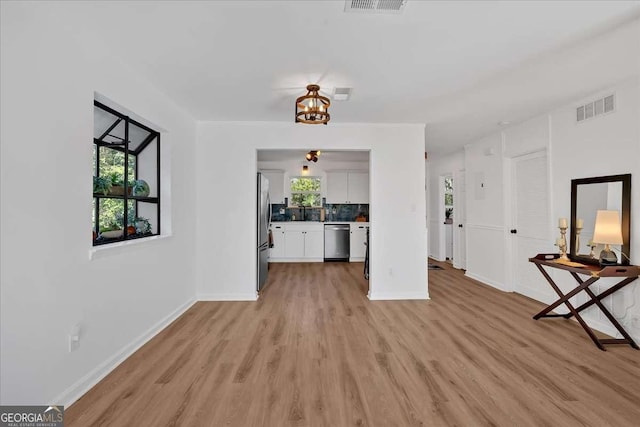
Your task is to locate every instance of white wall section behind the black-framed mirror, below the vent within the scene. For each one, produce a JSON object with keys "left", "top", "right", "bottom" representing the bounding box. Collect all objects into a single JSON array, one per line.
[{"left": 550, "top": 76, "right": 640, "bottom": 341}]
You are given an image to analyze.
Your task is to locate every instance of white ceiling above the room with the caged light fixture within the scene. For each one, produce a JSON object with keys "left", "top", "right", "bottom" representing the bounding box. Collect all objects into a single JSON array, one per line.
[{"left": 42, "top": 0, "right": 640, "bottom": 152}]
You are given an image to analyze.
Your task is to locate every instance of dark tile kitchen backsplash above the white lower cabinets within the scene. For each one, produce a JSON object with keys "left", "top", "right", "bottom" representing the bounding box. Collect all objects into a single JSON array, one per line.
[{"left": 271, "top": 203, "right": 369, "bottom": 222}]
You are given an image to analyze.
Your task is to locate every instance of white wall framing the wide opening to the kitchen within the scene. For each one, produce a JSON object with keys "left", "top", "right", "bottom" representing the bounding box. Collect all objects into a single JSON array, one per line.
[{"left": 196, "top": 122, "right": 428, "bottom": 300}]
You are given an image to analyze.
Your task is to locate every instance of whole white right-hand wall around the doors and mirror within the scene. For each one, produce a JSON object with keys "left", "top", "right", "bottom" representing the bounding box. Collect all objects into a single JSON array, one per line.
[{"left": 429, "top": 76, "right": 640, "bottom": 339}]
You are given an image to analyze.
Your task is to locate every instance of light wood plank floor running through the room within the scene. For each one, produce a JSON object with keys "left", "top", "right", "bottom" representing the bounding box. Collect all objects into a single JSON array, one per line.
[{"left": 65, "top": 263, "right": 640, "bottom": 427}]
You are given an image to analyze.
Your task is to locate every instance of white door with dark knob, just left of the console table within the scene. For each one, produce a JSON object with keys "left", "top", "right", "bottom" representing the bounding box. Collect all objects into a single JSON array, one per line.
[{"left": 509, "top": 151, "right": 556, "bottom": 302}]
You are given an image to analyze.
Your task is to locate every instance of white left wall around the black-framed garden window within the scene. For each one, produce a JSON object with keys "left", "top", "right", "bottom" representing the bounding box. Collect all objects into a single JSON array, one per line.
[{"left": 0, "top": 2, "right": 195, "bottom": 405}]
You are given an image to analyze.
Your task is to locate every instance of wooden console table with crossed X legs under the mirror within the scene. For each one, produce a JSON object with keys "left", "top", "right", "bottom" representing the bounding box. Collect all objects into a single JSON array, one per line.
[{"left": 529, "top": 254, "right": 640, "bottom": 351}]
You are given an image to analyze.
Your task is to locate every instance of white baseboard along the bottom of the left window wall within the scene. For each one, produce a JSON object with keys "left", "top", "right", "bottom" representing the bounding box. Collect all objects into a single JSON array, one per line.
[{"left": 57, "top": 299, "right": 196, "bottom": 408}]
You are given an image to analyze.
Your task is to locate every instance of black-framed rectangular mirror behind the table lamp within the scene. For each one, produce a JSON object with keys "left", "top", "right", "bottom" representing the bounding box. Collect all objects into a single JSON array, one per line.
[{"left": 569, "top": 174, "right": 631, "bottom": 265}]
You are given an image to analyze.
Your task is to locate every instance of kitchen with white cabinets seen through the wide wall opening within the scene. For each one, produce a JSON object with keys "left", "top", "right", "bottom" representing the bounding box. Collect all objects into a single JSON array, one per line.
[{"left": 256, "top": 147, "right": 375, "bottom": 298}]
